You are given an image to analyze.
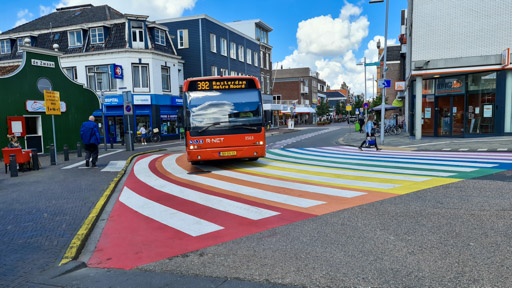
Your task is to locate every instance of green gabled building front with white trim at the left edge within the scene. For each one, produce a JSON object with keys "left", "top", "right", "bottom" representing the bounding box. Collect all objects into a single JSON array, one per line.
[{"left": 0, "top": 47, "right": 100, "bottom": 160}]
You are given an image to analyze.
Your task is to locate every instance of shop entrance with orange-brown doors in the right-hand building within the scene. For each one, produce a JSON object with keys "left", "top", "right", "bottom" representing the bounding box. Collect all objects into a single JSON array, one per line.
[{"left": 435, "top": 95, "right": 464, "bottom": 137}]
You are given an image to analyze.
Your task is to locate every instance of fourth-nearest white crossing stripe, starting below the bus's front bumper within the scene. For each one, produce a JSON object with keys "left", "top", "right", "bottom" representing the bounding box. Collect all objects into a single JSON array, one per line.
[{"left": 201, "top": 164, "right": 366, "bottom": 198}]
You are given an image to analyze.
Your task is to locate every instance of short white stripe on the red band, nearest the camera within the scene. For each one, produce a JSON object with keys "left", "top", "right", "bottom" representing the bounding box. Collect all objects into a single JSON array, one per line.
[{"left": 119, "top": 187, "right": 224, "bottom": 237}]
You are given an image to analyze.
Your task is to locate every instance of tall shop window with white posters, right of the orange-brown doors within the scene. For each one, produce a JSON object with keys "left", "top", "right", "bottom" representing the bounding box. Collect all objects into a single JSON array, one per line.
[{"left": 466, "top": 72, "right": 496, "bottom": 134}]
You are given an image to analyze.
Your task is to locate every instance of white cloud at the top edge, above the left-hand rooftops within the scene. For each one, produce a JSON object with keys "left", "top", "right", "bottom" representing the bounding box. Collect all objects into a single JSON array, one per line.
[{"left": 57, "top": 0, "right": 197, "bottom": 20}]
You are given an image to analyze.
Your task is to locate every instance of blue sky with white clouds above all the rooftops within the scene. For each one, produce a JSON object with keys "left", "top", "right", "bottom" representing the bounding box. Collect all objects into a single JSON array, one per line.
[{"left": 0, "top": 0, "right": 407, "bottom": 98}]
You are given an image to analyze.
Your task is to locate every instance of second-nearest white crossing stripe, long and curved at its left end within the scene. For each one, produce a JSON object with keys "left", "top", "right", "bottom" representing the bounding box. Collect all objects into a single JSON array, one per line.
[{"left": 133, "top": 155, "right": 279, "bottom": 220}]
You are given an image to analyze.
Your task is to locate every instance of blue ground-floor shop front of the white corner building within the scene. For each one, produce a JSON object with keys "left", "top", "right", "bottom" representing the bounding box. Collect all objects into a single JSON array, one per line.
[{"left": 93, "top": 94, "right": 183, "bottom": 143}]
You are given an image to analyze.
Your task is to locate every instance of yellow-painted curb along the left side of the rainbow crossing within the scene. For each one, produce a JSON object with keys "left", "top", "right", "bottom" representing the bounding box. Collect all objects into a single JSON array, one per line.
[{"left": 59, "top": 149, "right": 166, "bottom": 266}]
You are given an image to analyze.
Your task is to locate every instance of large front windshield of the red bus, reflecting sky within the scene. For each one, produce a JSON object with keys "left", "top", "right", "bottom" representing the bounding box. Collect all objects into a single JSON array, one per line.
[{"left": 186, "top": 89, "right": 262, "bottom": 132}]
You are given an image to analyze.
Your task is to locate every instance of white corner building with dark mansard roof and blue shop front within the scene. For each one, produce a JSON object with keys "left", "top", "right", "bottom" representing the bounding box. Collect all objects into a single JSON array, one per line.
[{"left": 0, "top": 5, "right": 184, "bottom": 141}]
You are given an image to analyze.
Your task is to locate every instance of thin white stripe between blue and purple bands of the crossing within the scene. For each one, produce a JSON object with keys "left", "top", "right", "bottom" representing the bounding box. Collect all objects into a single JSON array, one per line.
[{"left": 300, "top": 148, "right": 498, "bottom": 169}]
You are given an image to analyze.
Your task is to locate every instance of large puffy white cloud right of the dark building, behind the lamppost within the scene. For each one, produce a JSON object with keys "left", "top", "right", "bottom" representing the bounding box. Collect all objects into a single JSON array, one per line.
[{"left": 278, "top": 2, "right": 396, "bottom": 97}]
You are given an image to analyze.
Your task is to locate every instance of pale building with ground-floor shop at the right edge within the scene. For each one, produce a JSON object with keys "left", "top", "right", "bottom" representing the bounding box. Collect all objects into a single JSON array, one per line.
[{"left": 404, "top": 0, "right": 512, "bottom": 139}]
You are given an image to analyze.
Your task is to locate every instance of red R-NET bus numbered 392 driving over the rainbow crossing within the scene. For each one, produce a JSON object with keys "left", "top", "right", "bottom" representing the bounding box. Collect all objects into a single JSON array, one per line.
[{"left": 178, "top": 76, "right": 266, "bottom": 165}]
